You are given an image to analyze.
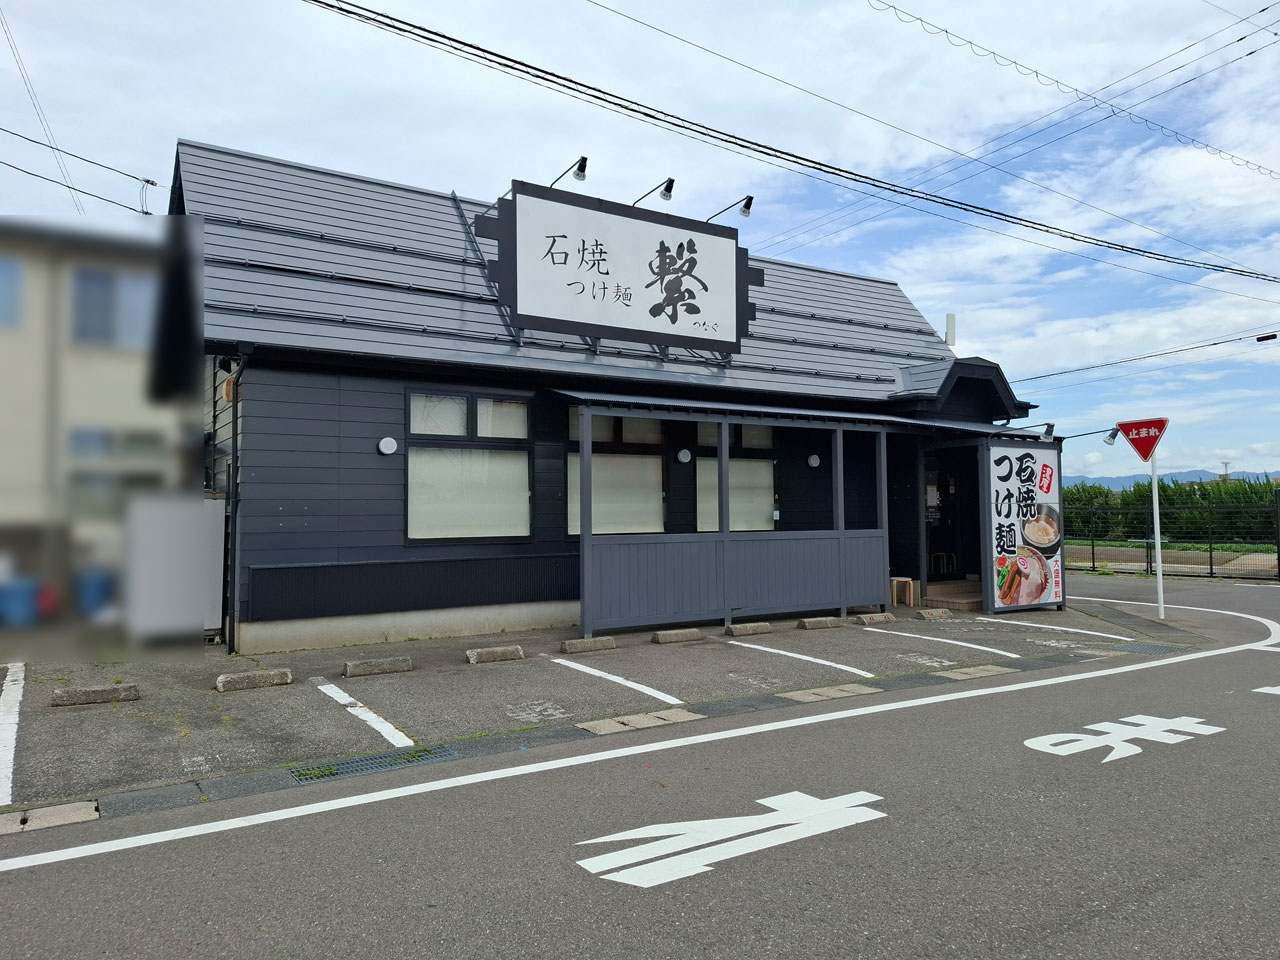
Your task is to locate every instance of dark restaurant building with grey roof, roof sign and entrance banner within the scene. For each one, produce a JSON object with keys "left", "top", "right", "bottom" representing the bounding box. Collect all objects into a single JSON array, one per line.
[{"left": 170, "top": 141, "right": 1062, "bottom": 653}]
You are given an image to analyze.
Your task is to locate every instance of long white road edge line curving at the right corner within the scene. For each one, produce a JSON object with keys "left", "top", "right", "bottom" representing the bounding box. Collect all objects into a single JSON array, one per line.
[{"left": 0, "top": 598, "right": 1280, "bottom": 873}]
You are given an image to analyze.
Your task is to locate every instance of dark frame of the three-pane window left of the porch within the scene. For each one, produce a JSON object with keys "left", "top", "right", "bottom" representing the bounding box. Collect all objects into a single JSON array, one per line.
[{"left": 401, "top": 384, "right": 540, "bottom": 547}]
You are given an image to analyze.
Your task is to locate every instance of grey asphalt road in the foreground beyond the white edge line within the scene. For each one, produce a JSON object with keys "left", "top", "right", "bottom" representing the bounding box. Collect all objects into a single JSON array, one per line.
[{"left": 0, "top": 579, "right": 1280, "bottom": 960}]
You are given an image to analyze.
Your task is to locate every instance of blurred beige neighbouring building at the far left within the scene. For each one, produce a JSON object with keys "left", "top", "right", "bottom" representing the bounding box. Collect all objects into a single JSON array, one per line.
[{"left": 0, "top": 219, "right": 179, "bottom": 613}]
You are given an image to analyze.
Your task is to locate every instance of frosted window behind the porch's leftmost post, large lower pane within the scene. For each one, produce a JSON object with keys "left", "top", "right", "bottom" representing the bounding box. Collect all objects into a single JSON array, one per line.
[{"left": 566, "top": 453, "right": 664, "bottom": 535}]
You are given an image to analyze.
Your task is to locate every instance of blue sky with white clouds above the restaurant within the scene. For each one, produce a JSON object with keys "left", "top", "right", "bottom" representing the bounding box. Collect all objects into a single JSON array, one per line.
[{"left": 0, "top": 0, "right": 1280, "bottom": 476}]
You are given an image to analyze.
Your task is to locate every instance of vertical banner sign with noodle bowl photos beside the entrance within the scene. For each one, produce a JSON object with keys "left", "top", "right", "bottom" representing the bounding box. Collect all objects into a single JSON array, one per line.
[{"left": 987, "top": 444, "right": 1064, "bottom": 609}]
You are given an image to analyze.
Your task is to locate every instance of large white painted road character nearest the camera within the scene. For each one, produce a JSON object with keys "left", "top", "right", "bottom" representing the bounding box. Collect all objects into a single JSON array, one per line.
[{"left": 577, "top": 791, "right": 884, "bottom": 887}]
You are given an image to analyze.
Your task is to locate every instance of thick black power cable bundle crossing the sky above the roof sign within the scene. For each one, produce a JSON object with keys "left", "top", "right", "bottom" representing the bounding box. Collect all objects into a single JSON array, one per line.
[{"left": 296, "top": 0, "right": 1280, "bottom": 283}]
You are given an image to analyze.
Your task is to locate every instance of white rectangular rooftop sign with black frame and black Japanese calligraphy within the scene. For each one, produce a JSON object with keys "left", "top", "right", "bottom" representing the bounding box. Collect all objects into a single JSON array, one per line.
[{"left": 475, "top": 180, "right": 764, "bottom": 353}]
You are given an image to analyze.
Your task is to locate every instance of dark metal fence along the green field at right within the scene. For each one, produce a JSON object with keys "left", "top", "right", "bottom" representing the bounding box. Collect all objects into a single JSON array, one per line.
[{"left": 1062, "top": 495, "right": 1280, "bottom": 580}]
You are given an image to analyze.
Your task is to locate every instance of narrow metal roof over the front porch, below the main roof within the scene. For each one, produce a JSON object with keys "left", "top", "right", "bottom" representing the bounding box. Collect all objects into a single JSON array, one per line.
[{"left": 556, "top": 390, "right": 1044, "bottom": 440}]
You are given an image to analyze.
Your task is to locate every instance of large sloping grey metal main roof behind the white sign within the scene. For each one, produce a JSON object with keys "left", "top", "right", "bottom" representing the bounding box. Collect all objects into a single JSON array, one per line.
[{"left": 172, "top": 141, "right": 954, "bottom": 401}]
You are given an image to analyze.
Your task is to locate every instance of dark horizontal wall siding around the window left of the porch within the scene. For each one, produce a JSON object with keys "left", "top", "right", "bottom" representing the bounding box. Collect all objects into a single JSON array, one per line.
[{"left": 239, "top": 361, "right": 577, "bottom": 620}]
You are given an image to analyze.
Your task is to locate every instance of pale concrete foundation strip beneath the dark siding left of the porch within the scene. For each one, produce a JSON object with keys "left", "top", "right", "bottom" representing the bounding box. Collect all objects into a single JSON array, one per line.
[{"left": 236, "top": 600, "right": 579, "bottom": 654}]
